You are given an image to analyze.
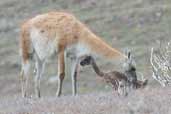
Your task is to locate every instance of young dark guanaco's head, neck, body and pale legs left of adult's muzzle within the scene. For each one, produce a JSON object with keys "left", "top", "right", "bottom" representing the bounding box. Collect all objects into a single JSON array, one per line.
[{"left": 80, "top": 56, "right": 130, "bottom": 96}]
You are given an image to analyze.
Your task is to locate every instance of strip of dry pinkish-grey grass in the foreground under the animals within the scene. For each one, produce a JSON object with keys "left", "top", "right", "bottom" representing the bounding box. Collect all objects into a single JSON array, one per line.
[{"left": 0, "top": 87, "right": 171, "bottom": 114}]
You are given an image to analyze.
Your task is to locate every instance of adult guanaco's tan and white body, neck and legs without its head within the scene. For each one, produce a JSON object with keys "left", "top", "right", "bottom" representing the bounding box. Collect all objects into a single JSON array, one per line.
[{"left": 20, "top": 12, "right": 126, "bottom": 97}]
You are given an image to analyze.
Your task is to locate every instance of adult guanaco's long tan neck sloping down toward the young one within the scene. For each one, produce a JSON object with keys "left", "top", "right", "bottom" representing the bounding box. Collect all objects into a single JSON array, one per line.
[{"left": 80, "top": 24, "right": 127, "bottom": 59}]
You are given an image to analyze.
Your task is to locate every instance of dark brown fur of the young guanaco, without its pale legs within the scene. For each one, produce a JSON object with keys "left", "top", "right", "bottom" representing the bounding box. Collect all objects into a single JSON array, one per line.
[{"left": 80, "top": 56, "right": 148, "bottom": 93}]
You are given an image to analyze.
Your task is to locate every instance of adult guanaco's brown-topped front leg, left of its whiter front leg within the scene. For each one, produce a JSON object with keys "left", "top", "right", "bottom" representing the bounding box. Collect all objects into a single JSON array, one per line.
[{"left": 56, "top": 50, "right": 65, "bottom": 97}]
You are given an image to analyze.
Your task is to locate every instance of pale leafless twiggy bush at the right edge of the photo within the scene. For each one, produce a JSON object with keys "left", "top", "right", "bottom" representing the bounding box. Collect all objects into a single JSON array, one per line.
[{"left": 150, "top": 41, "right": 171, "bottom": 87}]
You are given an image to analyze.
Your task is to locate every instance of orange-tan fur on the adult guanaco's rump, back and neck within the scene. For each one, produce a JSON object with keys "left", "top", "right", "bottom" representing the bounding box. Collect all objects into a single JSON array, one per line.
[{"left": 20, "top": 12, "right": 126, "bottom": 59}]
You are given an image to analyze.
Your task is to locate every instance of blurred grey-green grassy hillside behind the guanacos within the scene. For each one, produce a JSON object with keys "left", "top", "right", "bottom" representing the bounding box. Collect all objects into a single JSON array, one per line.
[{"left": 0, "top": 0, "right": 171, "bottom": 98}]
